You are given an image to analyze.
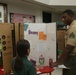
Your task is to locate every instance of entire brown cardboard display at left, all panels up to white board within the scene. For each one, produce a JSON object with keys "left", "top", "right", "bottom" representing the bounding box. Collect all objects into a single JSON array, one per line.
[{"left": 0, "top": 23, "right": 24, "bottom": 75}]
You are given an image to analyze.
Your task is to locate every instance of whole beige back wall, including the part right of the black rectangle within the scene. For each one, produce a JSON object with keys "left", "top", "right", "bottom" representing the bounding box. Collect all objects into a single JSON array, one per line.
[{"left": 8, "top": 4, "right": 60, "bottom": 23}]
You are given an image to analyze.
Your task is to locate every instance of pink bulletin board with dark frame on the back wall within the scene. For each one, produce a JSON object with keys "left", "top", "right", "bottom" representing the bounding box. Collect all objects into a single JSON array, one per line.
[{"left": 10, "top": 13, "right": 35, "bottom": 23}]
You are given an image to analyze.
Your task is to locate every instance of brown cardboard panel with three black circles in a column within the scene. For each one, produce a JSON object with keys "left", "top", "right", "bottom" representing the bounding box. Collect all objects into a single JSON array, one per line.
[{"left": 0, "top": 23, "right": 13, "bottom": 75}]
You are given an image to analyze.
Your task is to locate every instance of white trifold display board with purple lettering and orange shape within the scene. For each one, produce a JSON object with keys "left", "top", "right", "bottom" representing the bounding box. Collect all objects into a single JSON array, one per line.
[{"left": 24, "top": 23, "right": 56, "bottom": 65}]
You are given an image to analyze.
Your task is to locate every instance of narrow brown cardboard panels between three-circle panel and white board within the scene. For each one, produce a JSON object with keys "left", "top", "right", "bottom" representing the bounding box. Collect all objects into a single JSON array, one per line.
[{"left": 12, "top": 23, "right": 24, "bottom": 57}]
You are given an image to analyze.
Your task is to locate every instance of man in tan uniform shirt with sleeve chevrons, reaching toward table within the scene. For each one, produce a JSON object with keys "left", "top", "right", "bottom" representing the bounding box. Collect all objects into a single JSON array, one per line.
[{"left": 50, "top": 9, "right": 76, "bottom": 75}]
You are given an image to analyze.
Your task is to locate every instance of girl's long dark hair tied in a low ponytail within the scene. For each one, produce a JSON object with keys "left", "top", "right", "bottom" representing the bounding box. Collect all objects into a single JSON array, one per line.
[{"left": 14, "top": 39, "right": 30, "bottom": 71}]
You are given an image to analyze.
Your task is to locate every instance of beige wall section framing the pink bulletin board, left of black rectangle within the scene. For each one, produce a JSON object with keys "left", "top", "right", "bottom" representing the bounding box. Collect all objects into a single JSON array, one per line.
[{"left": 8, "top": 4, "right": 42, "bottom": 23}]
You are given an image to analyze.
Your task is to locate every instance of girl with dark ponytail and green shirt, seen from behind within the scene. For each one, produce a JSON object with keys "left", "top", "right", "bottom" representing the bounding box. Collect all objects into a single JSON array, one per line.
[{"left": 12, "top": 39, "right": 37, "bottom": 75}]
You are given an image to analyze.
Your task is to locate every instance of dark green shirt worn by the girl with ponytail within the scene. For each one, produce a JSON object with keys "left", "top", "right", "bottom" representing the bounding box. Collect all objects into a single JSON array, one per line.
[{"left": 12, "top": 56, "right": 37, "bottom": 75}]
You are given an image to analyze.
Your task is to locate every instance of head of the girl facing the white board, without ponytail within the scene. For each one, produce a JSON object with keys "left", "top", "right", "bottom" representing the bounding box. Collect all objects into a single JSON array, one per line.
[{"left": 17, "top": 39, "right": 30, "bottom": 57}]
